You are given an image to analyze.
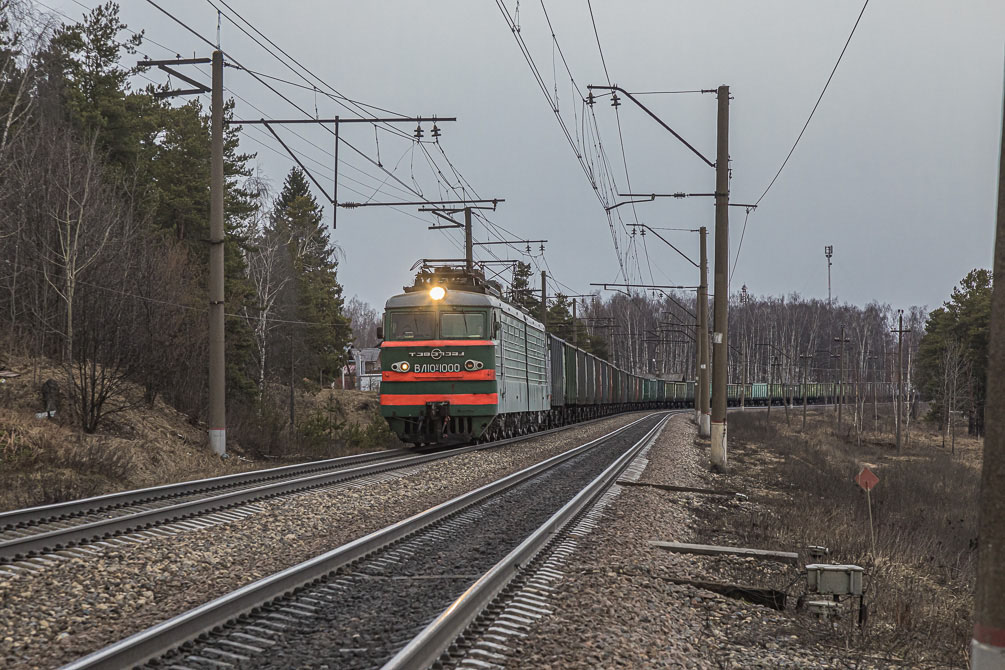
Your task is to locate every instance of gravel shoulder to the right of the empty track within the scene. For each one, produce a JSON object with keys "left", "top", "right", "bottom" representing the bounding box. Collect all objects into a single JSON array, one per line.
[{"left": 505, "top": 415, "right": 920, "bottom": 670}]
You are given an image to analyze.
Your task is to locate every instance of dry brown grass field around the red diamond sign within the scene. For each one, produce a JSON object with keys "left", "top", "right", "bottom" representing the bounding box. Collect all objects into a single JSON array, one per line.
[{"left": 730, "top": 408, "right": 981, "bottom": 666}]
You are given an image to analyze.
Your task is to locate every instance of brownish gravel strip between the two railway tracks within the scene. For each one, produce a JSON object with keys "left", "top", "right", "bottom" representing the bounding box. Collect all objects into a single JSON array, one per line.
[{"left": 0, "top": 413, "right": 644, "bottom": 669}]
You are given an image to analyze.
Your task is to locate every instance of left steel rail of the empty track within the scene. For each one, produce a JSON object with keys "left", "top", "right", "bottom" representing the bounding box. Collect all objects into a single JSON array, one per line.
[{"left": 62, "top": 414, "right": 652, "bottom": 670}]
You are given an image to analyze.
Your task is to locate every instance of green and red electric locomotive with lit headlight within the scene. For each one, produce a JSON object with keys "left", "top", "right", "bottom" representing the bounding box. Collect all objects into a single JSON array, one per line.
[{"left": 378, "top": 268, "right": 534, "bottom": 445}]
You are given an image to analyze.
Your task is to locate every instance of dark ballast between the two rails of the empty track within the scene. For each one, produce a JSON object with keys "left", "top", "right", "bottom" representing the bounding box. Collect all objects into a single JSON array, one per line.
[{"left": 163, "top": 417, "right": 659, "bottom": 670}]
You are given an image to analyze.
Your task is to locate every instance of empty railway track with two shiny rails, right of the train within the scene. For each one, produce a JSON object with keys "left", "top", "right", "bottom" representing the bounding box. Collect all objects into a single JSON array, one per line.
[{"left": 58, "top": 412, "right": 668, "bottom": 669}]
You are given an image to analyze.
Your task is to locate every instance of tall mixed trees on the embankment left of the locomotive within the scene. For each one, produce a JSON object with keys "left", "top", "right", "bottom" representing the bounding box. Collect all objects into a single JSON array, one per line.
[{"left": 0, "top": 5, "right": 353, "bottom": 445}]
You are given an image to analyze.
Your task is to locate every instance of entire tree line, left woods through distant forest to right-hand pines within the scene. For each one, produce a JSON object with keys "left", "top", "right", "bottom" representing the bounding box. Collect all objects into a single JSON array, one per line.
[{"left": 0, "top": 0, "right": 991, "bottom": 450}]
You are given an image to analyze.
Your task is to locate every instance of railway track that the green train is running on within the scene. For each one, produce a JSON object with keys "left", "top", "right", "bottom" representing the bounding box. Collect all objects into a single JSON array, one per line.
[{"left": 0, "top": 409, "right": 643, "bottom": 573}]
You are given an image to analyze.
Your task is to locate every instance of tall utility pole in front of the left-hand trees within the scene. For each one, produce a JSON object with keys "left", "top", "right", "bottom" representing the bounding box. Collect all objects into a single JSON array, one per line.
[{"left": 209, "top": 51, "right": 227, "bottom": 456}]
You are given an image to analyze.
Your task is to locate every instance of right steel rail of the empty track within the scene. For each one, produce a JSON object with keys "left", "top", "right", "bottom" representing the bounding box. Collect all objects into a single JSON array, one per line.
[{"left": 381, "top": 414, "right": 670, "bottom": 670}]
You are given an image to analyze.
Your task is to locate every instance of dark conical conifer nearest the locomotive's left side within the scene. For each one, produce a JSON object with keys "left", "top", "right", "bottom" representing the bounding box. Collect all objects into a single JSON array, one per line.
[{"left": 272, "top": 168, "right": 352, "bottom": 378}]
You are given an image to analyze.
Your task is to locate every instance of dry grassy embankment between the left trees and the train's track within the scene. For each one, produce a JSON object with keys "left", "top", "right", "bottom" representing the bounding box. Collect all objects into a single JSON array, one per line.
[{"left": 0, "top": 361, "right": 400, "bottom": 510}]
